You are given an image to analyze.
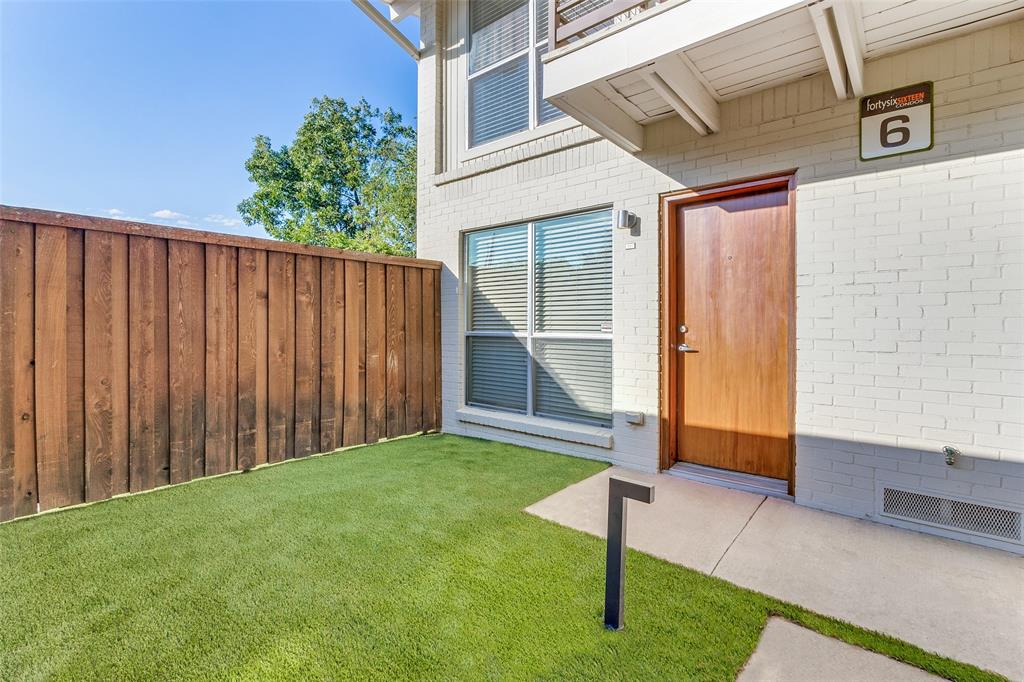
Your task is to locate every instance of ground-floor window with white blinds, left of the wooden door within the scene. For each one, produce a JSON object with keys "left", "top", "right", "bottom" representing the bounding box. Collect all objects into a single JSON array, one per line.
[{"left": 465, "top": 206, "right": 612, "bottom": 426}]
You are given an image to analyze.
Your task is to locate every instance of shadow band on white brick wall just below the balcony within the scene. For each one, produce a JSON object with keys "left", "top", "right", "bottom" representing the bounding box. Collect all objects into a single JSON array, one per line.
[{"left": 635, "top": 60, "right": 1024, "bottom": 187}]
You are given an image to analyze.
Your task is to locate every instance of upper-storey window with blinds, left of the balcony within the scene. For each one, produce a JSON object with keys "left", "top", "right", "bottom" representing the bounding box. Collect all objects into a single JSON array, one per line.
[{"left": 467, "top": 0, "right": 565, "bottom": 147}]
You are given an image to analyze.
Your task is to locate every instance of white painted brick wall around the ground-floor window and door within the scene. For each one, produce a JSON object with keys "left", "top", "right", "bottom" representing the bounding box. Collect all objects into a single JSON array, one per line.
[{"left": 419, "top": 2, "right": 1024, "bottom": 540}]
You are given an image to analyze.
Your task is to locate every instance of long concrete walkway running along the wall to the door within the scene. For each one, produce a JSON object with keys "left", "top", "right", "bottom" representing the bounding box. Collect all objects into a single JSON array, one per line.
[{"left": 526, "top": 467, "right": 1024, "bottom": 680}]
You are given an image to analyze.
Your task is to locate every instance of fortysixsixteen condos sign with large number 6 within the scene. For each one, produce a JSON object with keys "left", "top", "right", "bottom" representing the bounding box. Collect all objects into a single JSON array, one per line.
[{"left": 860, "top": 81, "right": 935, "bottom": 161}]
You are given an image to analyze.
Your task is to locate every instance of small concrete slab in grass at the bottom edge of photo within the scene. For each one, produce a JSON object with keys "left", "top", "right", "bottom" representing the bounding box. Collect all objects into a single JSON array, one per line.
[{"left": 736, "top": 619, "right": 942, "bottom": 682}]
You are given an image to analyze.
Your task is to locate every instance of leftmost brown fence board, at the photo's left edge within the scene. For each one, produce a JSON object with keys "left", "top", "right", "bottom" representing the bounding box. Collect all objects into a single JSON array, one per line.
[{"left": 0, "top": 220, "right": 39, "bottom": 521}]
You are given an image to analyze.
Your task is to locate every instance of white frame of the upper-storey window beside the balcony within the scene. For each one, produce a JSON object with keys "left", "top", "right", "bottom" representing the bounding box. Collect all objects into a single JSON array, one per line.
[{"left": 458, "top": 0, "right": 580, "bottom": 162}]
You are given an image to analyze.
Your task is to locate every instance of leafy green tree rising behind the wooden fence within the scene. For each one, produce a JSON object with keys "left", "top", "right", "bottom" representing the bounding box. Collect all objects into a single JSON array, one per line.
[{"left": 239, "top": 97, "right": 416, "bottom": 255}]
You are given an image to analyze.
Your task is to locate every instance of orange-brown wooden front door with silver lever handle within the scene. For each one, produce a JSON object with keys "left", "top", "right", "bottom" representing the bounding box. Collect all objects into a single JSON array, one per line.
[{"left": 667, "top": 178, "right": 795, "bottom": 480}]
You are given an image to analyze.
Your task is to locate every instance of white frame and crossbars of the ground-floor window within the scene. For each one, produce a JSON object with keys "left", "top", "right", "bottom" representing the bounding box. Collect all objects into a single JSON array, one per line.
[{"left": 461, "top": 206, "right": 614, "bottom": 428}]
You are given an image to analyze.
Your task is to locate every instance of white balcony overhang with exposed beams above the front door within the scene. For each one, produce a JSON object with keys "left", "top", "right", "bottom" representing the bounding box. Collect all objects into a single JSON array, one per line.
[{"left": 543, "top": 0, "right": 1024, "bottom": 153}]
